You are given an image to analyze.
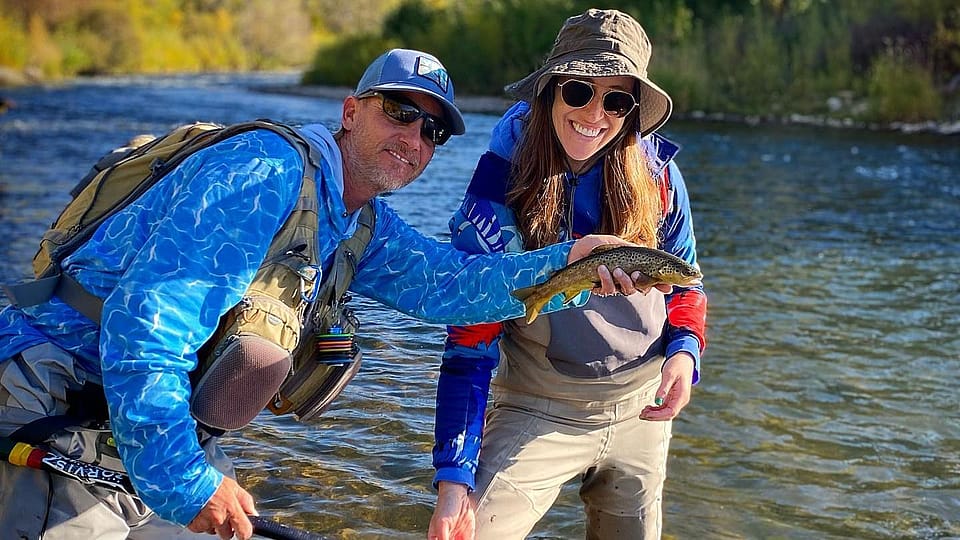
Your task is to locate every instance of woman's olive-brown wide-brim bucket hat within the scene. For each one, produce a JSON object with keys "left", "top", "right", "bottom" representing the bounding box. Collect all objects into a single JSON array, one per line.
[{"left": 504, "top": 9, "right": 673, "bottom": 136}]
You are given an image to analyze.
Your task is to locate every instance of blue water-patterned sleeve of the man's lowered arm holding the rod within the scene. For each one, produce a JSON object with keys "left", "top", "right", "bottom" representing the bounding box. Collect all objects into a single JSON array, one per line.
[{"left": 97, "top": 130, "right": 303, "bottom": 525}]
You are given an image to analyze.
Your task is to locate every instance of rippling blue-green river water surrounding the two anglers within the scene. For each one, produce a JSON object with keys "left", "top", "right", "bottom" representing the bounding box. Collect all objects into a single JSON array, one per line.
[{"left": 0, "top": 74, "right": 960, "bottom": 539}]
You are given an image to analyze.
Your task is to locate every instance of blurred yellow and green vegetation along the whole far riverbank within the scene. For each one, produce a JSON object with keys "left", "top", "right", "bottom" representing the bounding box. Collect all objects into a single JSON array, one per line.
[{"left": 0, "top": 0, "right": 960, "bottom": 123}]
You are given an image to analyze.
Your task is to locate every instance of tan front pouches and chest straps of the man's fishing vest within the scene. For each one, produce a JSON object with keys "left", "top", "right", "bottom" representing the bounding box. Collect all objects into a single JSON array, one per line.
[{"left": 190, "top": 200, "right": 376, "bottom": 433}]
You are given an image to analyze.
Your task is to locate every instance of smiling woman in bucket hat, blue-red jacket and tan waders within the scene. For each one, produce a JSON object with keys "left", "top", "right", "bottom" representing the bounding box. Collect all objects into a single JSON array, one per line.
[{"left": 428, "top": 9, "right": 706, "bottom": 540}]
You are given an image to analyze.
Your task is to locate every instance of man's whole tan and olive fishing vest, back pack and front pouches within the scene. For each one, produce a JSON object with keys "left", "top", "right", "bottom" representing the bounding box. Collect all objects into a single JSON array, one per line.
[{"left": 3, "top": 120, "right": 376, "bottom": 433}]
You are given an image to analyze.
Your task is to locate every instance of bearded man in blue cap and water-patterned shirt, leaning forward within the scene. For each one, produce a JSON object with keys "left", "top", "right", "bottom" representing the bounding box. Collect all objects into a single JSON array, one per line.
[{"left": 0, "top": 49, "right": 635, "bottom": 540}]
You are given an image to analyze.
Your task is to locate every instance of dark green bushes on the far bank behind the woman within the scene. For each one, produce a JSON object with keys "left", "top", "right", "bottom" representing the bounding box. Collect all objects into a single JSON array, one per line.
[{"left": 304, "top": 0, "right": 960, "bottom": 122}]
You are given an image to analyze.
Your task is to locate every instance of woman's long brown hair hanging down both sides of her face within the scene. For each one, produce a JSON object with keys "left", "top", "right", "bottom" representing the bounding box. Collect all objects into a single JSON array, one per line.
[{"left": 507, "top": 84, "right": 662, "bottom": 249}]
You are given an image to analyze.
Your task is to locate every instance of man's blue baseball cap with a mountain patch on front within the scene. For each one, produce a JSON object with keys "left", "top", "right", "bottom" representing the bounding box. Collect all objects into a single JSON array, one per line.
[{"left": 353, "top": 49, "right": 466, "bottom": 135}]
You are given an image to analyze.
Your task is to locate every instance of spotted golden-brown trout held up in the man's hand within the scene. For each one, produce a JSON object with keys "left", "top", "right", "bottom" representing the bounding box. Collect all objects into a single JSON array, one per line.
[{"left": 510, "top": 246, "right": 703, "bottom": 324}]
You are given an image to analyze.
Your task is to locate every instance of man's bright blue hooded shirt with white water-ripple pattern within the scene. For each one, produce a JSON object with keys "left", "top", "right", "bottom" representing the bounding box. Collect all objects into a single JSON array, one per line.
[{"left": 0, "top": 125, "right": 569, "bottom": 525}]
